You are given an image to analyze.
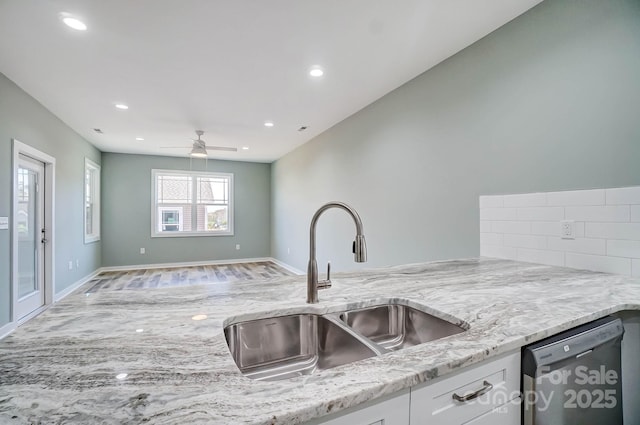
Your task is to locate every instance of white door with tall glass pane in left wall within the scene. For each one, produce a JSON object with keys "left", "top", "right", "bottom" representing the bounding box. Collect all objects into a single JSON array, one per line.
[{"left": 13, "top": 154, "right": 47, "bottom": 320}]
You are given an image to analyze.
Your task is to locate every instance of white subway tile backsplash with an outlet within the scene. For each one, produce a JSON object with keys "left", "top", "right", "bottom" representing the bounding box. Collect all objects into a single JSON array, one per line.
[{"left": 480, "top": 186, "right": 640, "bottom": 276}]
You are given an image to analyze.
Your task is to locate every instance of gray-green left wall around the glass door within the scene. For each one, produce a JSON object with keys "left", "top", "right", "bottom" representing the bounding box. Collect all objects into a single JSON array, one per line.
[{"left": 0, "top": 74, "right": 101, "bottom": 326}]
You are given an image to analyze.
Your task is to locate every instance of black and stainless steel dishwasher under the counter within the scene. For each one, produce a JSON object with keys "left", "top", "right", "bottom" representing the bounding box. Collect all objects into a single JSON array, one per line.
[{"left": 522, "top": 317, "right": 624, "bottom": 425}]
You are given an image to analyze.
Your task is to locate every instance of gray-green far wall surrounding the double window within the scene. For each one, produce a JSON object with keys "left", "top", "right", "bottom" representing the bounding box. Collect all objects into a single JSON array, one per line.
[{"left": 102, "top": 153, "right": 271, "bottom": 267}]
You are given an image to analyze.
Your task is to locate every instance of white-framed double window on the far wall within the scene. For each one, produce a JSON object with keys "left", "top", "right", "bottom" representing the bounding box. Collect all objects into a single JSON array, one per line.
[{"left": 151, "top": 170, "right": 233, "bottom": 237}]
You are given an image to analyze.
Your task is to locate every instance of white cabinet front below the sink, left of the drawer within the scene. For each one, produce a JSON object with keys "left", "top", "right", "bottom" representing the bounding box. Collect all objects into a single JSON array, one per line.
[{"left": 307, "top": 390, "right": 409, "bottom": 425}]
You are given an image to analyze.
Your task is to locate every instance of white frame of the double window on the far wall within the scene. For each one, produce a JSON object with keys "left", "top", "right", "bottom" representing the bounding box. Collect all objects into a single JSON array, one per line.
[{"left": 151, "top": 169, "right": 234, "bottom": 238}]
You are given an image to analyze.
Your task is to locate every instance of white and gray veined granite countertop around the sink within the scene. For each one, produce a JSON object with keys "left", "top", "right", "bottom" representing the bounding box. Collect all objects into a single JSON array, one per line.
[{"left": 0, "top": 258, "right": 640, "bottom": 425}]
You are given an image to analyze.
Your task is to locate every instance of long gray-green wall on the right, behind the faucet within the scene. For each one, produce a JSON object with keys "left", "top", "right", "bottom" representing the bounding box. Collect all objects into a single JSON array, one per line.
[{"left": 271, "top": 0, "right": 640, "bottom": 269}]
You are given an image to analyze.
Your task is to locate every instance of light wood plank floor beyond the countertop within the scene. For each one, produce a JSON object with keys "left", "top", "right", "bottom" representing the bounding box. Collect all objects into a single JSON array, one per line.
[{"left": 85, "top": 261, "right": 293, "bottom": 293}]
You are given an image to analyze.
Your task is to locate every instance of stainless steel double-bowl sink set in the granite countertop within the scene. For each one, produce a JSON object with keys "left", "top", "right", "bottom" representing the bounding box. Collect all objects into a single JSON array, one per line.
[{"left": 224, "top": 301, "right": 468, "bottom": 381}]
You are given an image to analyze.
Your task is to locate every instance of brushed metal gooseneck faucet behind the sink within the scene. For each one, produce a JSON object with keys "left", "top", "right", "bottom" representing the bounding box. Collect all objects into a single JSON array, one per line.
[{"left": 307, "top": 202, "right": 367, "bottom": 304}]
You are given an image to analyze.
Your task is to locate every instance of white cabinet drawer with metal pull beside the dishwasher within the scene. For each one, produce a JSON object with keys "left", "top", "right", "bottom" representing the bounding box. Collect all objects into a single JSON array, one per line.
[{"left": 411, "top": 351, "right": 520, "bottom": 425}]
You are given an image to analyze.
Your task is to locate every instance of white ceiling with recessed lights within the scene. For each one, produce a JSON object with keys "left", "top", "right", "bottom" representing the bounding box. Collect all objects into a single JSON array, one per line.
[{"left": 0, "top": 0, "right": 541, "bottom": 162}]
